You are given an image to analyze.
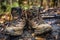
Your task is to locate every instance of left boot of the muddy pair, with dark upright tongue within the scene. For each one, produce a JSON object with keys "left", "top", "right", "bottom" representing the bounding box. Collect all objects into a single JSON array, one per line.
[{"left": 5, "top": 8, "right": 26, "bottom": 36}]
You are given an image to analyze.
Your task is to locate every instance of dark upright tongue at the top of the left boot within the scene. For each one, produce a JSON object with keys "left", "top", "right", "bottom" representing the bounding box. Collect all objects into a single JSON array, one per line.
[{"left": 11, "top": 7, "right": 22, "bottom": 18}]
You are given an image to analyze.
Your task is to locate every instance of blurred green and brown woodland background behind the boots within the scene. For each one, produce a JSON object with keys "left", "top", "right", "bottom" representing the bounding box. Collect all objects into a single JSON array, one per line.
[{"left": 0, "top": 0, "right": 60, "bottom": 14}]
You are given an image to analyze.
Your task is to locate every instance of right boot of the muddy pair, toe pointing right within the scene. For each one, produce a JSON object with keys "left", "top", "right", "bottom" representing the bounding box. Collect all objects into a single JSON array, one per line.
[{"left": 28, "top": 9, "right": 51, "bottom": 34}]
